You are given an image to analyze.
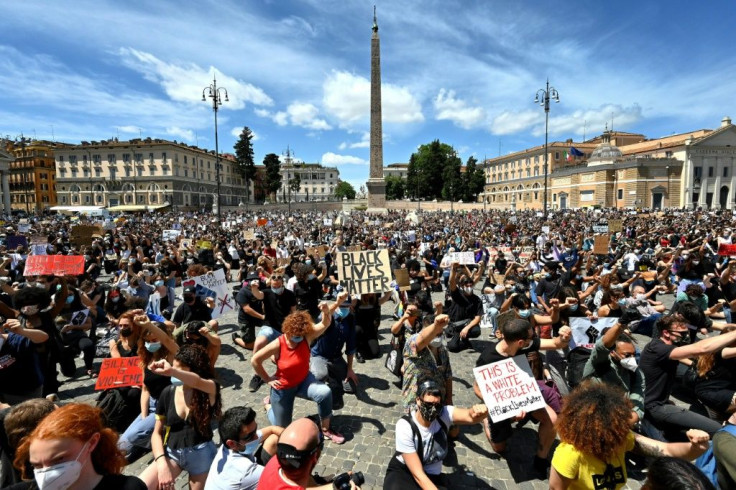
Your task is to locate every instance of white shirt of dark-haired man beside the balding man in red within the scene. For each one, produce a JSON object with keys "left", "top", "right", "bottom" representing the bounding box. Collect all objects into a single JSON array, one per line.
[{"left": 204, "top": 444, "right": 263, "bottom": 490}]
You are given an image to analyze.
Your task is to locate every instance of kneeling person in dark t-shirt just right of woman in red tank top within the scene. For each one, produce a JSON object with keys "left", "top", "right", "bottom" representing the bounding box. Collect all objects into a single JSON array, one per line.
[{"left": 309, "top": 294, "right": 358, "bottom": 410}]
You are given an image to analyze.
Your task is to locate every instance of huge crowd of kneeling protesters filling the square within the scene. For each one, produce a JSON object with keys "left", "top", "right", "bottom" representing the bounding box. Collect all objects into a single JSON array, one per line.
[{"left": 0, "top": 205, "right": 736, "bottom": 490}]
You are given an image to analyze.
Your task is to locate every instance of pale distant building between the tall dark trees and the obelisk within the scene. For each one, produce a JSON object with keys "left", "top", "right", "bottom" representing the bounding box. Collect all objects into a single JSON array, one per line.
[{"left": 276, "top": 163, "right": 340, "bottom": 202}]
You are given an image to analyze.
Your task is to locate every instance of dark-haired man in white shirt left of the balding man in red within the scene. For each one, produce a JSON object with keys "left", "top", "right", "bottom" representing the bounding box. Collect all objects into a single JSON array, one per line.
[{"left": 204, "top": 407, "right": 283, "bottom": 490}]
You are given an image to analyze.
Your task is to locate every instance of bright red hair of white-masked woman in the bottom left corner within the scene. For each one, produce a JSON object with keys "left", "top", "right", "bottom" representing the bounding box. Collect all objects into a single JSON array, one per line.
[{"left": 13, "top": 403, "right": 126, "bottom": 479}]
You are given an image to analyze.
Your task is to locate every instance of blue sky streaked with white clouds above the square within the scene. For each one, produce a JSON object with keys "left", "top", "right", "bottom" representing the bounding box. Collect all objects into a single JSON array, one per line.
[{"left": 0, "top": 0, "right": 736, "bottom": 188}]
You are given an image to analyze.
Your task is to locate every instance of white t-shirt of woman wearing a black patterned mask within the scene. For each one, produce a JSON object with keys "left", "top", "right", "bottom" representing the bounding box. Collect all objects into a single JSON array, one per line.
[{"left": 396, "top": 405, "right": 455, "bottom": 475}]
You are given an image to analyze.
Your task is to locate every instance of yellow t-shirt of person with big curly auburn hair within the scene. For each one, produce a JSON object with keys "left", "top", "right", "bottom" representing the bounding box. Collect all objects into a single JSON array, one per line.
[{"left": 552, "top": 432, "right": 634, "bottom": 490}]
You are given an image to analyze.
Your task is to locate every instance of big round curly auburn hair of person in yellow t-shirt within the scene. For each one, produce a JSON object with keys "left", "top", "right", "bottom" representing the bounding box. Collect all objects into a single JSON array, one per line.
[{"left": 556, "top": 381, "right": 632, "bottom": 461}]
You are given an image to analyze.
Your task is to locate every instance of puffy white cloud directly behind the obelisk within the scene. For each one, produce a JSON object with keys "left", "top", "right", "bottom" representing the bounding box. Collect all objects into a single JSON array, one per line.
[{"left": 322, "top": 71, "right": 424, "bottom": 127}]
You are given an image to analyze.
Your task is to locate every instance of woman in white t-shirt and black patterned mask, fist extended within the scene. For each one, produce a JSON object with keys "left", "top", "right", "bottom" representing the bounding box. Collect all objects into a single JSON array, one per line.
[{"left": 383, "top": 381, "right": 488, "bottom": 490}]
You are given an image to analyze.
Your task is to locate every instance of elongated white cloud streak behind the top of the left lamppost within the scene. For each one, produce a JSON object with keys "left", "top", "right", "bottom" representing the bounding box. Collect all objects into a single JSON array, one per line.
[{"left": 119, "top": 48, "right": 273, "bottom": 109}]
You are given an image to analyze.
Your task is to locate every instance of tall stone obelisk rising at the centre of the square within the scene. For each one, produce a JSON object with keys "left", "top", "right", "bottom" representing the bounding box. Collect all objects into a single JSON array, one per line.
[{"left": 367, "top": 5, "right": 388, "bottom": 213}]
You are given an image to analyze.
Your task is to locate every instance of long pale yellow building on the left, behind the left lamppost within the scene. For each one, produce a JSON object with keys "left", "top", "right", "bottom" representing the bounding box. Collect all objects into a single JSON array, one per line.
[{"left": 56, "top": 138, "right": 249, "bottom": 209}]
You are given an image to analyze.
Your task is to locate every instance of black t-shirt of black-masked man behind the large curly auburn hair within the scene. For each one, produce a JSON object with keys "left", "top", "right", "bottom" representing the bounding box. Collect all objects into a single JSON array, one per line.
[{"left": 639, "top": 339, "right": 678, "bottom": 410}]
